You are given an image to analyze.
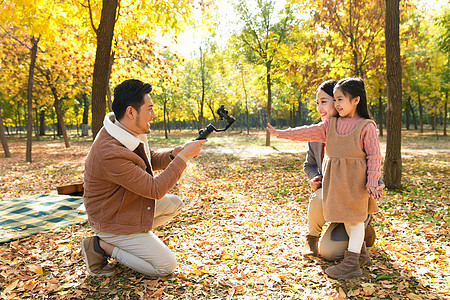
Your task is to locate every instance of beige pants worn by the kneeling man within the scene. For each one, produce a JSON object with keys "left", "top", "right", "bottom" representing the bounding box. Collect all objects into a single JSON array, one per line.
[{"left": 95, "top": 194, "right": 183, "bottom": 277}]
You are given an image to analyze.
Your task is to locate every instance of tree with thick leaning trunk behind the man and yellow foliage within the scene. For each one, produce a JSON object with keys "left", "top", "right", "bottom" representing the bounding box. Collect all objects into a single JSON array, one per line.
[{"left": 78, "top": 0, "right": 190, "bottom": 137}]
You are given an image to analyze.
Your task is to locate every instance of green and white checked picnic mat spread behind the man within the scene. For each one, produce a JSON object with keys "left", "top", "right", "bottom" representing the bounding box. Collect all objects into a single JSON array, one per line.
[{"left": 0, "top": 194, "right": 87, "bottom": 244}]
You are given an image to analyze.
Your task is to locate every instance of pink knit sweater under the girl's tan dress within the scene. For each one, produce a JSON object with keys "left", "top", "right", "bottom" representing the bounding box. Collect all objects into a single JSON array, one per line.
[{"left": 277, "top": 116, "right": 381, "bottom": 187}]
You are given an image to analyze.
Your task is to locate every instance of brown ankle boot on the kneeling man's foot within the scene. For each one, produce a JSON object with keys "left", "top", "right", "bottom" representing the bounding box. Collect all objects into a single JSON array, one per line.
[{"left": 81, "top": 236, "right": 114, "bottom": 276}]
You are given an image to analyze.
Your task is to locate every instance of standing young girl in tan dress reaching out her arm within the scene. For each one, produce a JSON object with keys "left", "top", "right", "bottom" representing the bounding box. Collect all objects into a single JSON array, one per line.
[{"left": 267, "top": 78, "right": 382, "bottom": 279}]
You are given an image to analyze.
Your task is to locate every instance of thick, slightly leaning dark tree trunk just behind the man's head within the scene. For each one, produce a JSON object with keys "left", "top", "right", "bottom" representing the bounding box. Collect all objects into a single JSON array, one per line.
[{"left": 92, "top": 0, "right": 118, "bottom": 139}]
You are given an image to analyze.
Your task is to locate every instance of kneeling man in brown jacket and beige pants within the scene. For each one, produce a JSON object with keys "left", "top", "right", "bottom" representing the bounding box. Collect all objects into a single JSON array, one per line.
[{"left": 81, "top": 79, "right": 206, "bottom": 277}]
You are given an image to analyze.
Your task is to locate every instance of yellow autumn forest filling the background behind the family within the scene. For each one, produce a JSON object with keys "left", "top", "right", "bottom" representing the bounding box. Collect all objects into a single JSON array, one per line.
[{"left": 0, "top": 0, "right": 450, "bottom": 155}]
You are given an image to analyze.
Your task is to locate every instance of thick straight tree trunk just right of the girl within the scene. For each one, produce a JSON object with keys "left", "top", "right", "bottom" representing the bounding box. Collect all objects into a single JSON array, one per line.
[{"left": 383, "top": 0, "right": 402, "bottom": 188}]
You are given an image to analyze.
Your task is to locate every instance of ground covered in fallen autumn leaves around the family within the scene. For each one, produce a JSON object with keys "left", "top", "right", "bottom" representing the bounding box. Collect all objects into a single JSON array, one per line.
[{"left": 0, "top": 135, "right": 450, "bottom": 300}]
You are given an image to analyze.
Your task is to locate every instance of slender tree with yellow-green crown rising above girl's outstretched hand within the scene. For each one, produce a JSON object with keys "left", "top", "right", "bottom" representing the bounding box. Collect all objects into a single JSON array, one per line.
[{"left": 235, "top": 0, "right": 293, "bottom": 146}]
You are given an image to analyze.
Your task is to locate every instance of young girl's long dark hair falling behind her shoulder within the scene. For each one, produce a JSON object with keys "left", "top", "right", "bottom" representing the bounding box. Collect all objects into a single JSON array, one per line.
[{"left": 334, "top": 77, "right": 372, "bottom": 119}]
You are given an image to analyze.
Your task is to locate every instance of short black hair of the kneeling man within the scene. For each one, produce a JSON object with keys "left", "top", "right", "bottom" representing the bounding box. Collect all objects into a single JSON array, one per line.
[{"left": 112, "top": 79, "right": 152, "bottom": 121}]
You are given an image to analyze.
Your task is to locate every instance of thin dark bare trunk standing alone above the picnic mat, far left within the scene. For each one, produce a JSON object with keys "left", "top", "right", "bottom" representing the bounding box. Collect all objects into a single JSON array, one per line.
[{"left": 25, "top": 36, "right": 40, "bottom": 163}]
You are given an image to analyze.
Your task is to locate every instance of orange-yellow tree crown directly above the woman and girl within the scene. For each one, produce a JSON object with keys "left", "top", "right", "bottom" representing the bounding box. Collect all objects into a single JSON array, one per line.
[{"left": 295, "top": 0, "right": 384, "bottom": 77}]
